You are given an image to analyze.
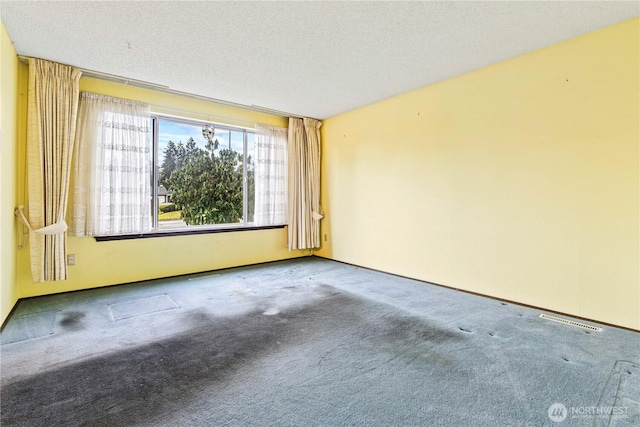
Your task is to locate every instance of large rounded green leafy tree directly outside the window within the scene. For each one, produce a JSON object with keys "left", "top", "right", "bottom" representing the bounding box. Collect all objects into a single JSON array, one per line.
[{"left": 169, "top": 141, "right": 243, "bottom": 225}]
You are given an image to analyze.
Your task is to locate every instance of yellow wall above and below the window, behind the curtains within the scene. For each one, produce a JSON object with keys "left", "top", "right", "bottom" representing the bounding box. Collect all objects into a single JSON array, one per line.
[{"left": 17, "top": 75, "right": 305, "bottom": 298}]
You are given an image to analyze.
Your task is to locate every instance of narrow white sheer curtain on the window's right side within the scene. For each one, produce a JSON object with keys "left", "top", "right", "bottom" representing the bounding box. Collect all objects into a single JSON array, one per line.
[{"left": 255, "top": 124, "right": 287, "bottom": 225}]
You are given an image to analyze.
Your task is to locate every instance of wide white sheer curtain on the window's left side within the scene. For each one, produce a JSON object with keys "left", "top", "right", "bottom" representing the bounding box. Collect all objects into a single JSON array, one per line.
[{"left": 71, "top": 92, "right": 151, "bottom": 236}]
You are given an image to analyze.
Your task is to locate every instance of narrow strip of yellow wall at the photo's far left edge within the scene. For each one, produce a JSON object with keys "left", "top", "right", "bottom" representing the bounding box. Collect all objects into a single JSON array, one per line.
[{"left": 0, "top": 21, "right": 18, "bottom": 324}]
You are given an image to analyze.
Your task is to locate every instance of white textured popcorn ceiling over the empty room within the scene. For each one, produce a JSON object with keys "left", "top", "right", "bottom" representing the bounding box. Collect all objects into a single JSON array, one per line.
[{"left": 0, "top": 0, "right": 640, "bottom": 119}]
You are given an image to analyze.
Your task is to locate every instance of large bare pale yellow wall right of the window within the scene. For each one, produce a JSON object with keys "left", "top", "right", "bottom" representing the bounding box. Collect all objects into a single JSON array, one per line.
[{"left": 318, "top": 19, "right": 640, "bottom": 329}]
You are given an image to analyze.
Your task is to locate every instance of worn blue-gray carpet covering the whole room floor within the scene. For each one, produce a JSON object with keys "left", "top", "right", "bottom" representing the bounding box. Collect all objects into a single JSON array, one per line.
[{"left": 0, "top": 258, "right": 640, "bottom": 427}]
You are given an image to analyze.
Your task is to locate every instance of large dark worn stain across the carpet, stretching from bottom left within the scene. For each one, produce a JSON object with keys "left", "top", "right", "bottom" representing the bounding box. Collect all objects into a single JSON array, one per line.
[{"left": 1, "top": 289, "right": 464, "bottom": 426}]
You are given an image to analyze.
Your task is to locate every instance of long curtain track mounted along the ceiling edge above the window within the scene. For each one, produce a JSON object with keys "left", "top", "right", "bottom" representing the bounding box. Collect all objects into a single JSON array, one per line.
[{"left": 18, "top": 55, "right": 312, "bottom": 119}]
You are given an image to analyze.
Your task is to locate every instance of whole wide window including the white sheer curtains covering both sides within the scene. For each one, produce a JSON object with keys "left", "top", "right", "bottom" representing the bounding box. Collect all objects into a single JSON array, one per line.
[{"left": 71, "top": 97, "right": 287, "bottom": 241}]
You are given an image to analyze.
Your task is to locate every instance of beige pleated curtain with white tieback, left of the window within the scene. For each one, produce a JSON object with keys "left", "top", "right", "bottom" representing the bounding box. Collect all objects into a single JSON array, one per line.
[{"left": 20, "top": 58, "right": 82, "bottom": 282}]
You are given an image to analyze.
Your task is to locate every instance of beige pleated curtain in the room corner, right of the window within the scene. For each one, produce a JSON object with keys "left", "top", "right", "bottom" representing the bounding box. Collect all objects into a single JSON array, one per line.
[{"left": 288, "top": 118, "right": 323, "bottom": 250}]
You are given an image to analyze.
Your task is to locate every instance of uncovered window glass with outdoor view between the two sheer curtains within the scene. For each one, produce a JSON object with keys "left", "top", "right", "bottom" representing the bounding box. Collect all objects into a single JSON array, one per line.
[{"left": 151, "top": 116, "right": 255, "bottom": 231}]
